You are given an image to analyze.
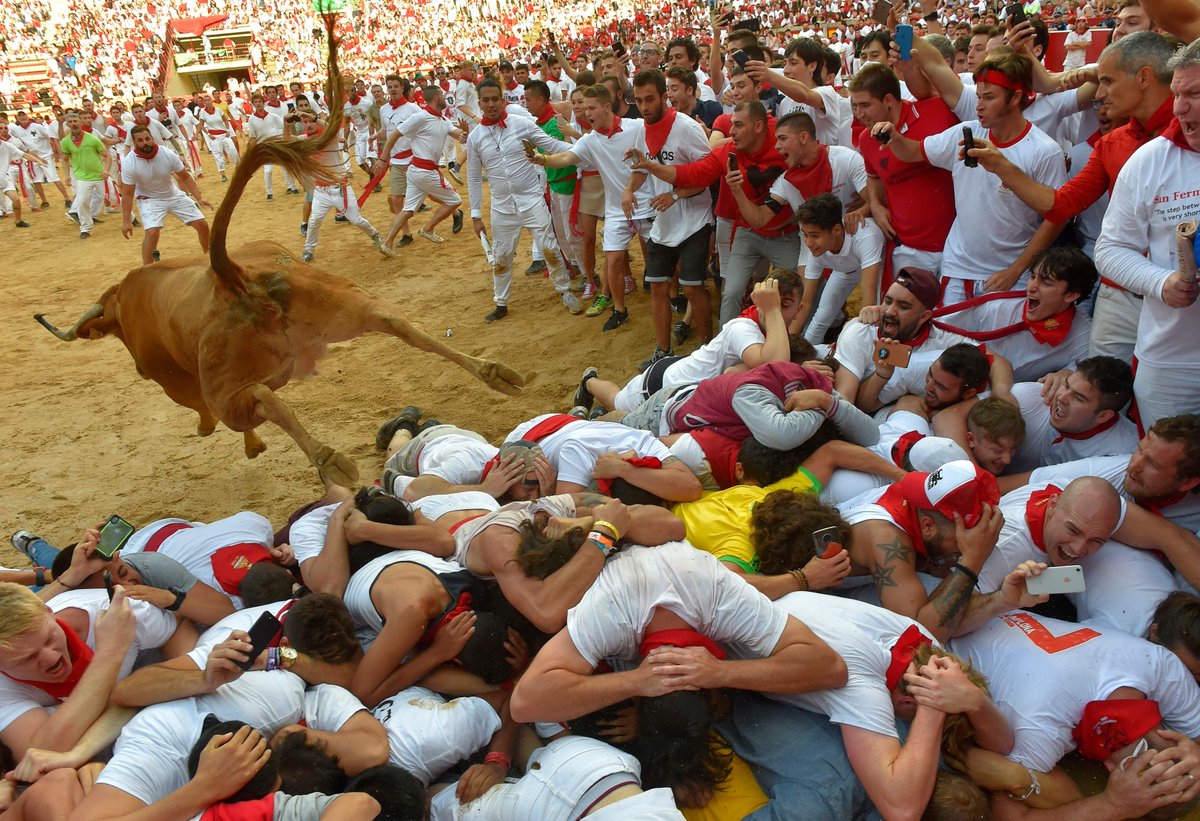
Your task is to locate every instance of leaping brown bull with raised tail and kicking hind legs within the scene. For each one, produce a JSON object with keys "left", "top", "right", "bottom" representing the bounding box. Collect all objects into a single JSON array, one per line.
[{"left": 35, "top": 18, "right": 524, "bottom": 486}]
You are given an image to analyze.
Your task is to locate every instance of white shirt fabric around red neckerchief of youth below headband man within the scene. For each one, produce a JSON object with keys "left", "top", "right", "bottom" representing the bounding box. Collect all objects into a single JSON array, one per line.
[{"left": 938, "top": 295, "right": 1092, "bottom": 382}]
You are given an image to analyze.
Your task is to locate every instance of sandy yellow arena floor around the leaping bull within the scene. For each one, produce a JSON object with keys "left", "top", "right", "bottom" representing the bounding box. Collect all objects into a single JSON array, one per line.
[{"left": 0, "top": 148, "right": 676, "bottom": 567}]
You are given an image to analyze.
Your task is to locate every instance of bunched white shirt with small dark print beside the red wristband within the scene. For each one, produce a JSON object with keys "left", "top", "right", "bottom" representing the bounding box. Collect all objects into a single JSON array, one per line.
[{"left": 371, "top": 687, "right": 500, "bottom": 786}]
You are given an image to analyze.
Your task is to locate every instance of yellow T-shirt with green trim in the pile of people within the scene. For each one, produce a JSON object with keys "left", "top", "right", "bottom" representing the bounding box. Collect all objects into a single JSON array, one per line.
[{"left": 674, "top": 468, "right": 821, "bottom": 573}]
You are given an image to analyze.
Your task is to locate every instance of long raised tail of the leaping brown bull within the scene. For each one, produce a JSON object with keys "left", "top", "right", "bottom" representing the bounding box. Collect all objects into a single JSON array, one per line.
[{"left": 209, "top": 14, "right": 343, "bottom": 295}]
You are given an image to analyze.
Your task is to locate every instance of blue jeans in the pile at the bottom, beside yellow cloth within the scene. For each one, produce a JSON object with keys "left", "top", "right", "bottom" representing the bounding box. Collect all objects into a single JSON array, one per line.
[{"left": 719, "top": 693, "right": 880, "bottom": 821}]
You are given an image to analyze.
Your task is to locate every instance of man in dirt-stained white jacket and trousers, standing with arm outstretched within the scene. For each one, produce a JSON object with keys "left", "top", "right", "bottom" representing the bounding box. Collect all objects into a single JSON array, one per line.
[{"left": 467, "top": 78, "right": 583, "bottom": 322}]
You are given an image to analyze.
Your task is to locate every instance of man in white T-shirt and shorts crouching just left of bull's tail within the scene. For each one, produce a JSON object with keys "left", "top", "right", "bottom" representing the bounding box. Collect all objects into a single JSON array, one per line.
[{"left": 121, "top": 125, "right": 212, "bottom": 265}]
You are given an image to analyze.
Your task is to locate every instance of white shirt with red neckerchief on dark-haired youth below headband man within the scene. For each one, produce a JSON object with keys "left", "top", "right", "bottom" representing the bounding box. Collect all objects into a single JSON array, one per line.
[{"left": 935, "top": 291, "right": 1092, "bottom": 382}]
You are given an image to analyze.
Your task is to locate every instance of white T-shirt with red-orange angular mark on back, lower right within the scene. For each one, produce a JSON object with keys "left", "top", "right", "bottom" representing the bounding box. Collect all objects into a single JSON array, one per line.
[{"left": 949, "top": 611, "right": 1200, "bottom": 773}]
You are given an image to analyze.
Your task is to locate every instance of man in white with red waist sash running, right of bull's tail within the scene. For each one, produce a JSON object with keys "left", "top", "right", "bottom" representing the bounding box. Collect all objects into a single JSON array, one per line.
[{"left": 383, "top": 85, "right": 467, "bottom": 248}]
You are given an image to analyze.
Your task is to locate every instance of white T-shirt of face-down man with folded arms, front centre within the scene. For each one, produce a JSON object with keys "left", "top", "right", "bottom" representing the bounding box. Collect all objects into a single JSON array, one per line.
[{"left": 566, "top": 541, "right": 788, "bottom": 670}]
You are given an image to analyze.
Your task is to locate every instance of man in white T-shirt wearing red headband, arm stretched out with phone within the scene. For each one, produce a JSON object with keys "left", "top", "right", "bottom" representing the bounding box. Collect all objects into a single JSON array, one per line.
[{"left": 871, "top": 54, "right": 1067, "bottom": 305}]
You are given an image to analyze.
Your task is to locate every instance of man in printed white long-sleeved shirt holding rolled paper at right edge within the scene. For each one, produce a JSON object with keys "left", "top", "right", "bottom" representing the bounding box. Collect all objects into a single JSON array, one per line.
[{"left": 1096, "top": 42, "right": 1200, "bottom": 430}]
